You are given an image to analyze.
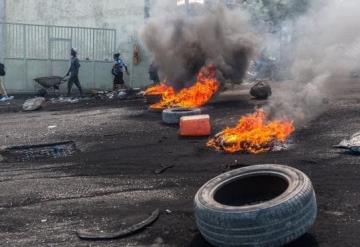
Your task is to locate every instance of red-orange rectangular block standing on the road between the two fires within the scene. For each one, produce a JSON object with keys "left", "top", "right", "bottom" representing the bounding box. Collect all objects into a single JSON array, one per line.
[{"left": 180, "top": 115, "right": 211, "bottom": 137}]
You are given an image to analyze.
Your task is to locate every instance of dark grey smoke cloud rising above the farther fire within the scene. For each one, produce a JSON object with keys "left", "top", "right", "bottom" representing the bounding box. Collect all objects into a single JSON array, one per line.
[{"left": 140, "top": 1, "right": 256, "bottom": 89}]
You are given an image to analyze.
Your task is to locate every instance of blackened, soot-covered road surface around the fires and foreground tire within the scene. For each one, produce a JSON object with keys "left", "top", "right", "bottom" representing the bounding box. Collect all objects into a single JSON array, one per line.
[{"left": 0, "top": 83, "right": 360, "bottom": 247}]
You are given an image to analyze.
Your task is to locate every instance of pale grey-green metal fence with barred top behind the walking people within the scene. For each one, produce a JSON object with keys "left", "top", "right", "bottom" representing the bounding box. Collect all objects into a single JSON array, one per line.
[{"left": 0, "top": 23, "right": 116, "bottom": 92}]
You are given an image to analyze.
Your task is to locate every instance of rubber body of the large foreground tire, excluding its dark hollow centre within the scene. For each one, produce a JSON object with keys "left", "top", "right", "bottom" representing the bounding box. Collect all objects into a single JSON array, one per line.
[{"left": 194, "top": 165, "right": 317, "bottom": 246}]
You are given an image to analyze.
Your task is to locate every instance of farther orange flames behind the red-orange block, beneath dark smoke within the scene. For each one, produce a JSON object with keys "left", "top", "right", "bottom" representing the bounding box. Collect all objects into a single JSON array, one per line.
[{"left": 145, "top": 65, "right": 220, "bottom": 109}]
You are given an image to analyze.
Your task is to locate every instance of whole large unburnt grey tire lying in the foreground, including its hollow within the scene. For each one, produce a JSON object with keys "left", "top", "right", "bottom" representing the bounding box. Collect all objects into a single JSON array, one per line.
[{"left": 194, "top": 165, "right": 317, "bottom": 247}]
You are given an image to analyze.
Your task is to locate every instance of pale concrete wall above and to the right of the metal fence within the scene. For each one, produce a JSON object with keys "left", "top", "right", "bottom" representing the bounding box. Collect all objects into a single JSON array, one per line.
[{"left": 4, "top": 0, "right": 153, "bottom": 87}]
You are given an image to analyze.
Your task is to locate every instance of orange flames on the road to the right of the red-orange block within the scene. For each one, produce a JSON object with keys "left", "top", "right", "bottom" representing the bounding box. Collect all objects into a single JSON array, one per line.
[{"left": 207, "top": 109, "right": 295, "bottom": 154}]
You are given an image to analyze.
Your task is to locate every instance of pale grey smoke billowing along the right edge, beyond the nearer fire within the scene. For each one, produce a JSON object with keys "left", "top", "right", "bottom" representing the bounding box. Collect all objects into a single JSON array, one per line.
[{"left": 267, "top": 0, "right": 360, "bottom": 124}]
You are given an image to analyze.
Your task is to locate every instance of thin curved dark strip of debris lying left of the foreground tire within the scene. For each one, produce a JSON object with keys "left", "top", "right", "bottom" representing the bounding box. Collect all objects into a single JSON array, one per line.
[{"left": 76, "top": 209, "right": 160, "bottom": 240}]
